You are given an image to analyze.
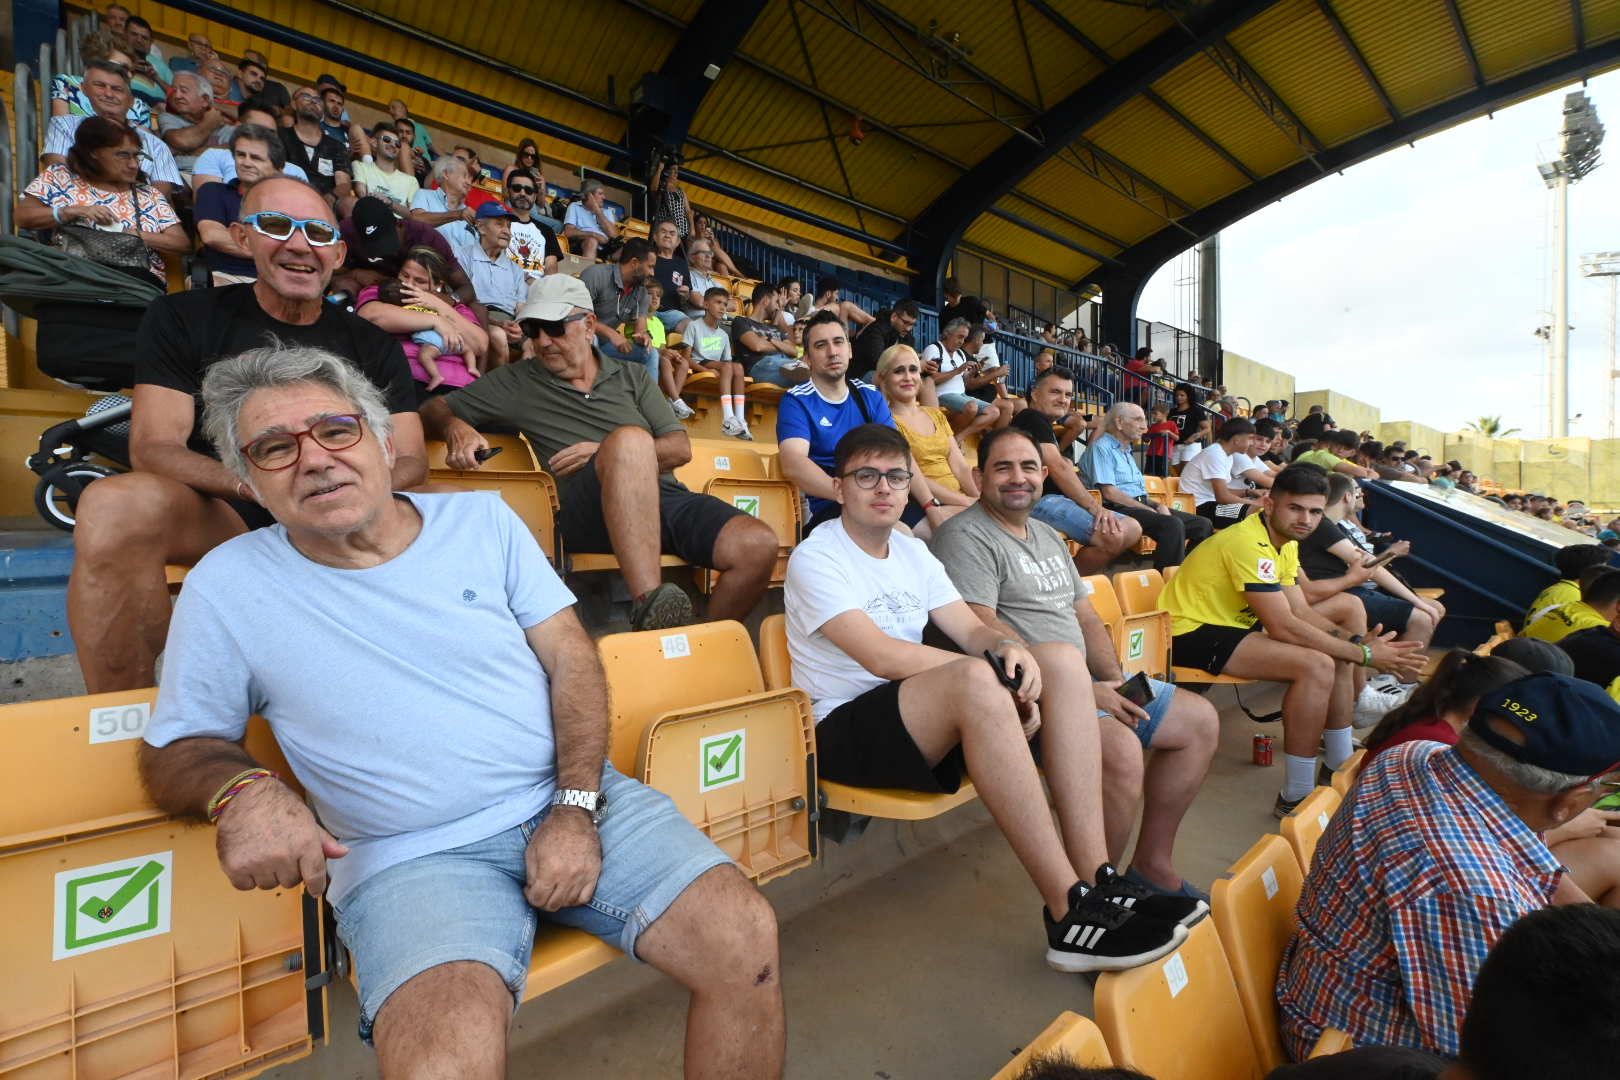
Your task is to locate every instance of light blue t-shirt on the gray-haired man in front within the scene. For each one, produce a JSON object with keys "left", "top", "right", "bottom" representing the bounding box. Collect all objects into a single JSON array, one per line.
[{"left": 146, "top": 492, "right": 573, "bottom": 904}]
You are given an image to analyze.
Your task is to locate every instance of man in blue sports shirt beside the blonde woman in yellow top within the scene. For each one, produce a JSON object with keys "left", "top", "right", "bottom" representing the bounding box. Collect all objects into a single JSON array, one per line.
[{"left": 776, "top": 311, "right": 944, "bottom": 536}]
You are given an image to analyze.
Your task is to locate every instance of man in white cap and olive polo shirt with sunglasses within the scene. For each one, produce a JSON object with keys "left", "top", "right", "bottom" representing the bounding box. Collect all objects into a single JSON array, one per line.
[{"left": 423, "top": 275, "right": 776, "bottom": 630}]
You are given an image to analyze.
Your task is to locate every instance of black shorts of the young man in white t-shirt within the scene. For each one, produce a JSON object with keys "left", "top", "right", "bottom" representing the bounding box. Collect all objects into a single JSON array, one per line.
[{"left": 815, "top": 682, "right": 967, "bottom": 795}]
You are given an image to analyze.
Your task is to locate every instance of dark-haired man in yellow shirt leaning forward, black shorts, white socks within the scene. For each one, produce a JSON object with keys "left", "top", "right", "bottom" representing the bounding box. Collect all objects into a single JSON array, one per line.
[{"left": 1158, "top": 465, "right": 1424, "bottom": 818}]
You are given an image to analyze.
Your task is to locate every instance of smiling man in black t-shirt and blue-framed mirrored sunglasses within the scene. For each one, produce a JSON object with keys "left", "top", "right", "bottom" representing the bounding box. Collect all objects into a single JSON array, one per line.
[{"left": 68, "top": 176, "right": 428, "bottom": 693}]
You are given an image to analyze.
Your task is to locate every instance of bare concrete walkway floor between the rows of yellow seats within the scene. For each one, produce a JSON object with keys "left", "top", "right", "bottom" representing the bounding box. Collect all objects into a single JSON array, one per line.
[{"left": 267, "top": 687, "right": 1281, "bottom": 1080}]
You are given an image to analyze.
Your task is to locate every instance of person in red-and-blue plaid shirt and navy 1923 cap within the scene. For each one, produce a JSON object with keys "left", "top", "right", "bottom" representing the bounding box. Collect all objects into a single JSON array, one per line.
[{"left": 1277, "top": 674, "right": 1620, "bottom": 1061}]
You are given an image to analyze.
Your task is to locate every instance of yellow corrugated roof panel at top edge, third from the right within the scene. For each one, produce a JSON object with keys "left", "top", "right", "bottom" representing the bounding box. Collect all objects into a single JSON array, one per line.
[{"left": 1333, "top": 0, "right": 1474, "bottom": 115}]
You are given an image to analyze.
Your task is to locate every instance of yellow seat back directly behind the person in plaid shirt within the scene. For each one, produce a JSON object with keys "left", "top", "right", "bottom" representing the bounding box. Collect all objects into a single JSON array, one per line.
[{"left": 1210, "top": 832, "right": 1304, "bottom": 1070}]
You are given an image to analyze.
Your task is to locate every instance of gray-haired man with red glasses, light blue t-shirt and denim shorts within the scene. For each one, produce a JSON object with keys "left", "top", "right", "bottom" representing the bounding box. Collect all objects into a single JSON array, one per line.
[{"left": 139, "top": 345, "right": 784, "bottom": 1077}]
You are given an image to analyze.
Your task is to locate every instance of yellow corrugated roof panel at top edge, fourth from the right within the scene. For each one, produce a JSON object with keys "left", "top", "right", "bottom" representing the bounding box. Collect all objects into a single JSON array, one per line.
[{"left": 1228, "top": 0, "right": 1390, "bottom": 146}]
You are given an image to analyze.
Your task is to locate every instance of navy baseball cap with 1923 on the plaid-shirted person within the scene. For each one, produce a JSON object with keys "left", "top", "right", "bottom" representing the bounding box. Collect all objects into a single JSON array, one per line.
[{"left": 1468, "top": 672, "right": 1620, "bottom": 777}]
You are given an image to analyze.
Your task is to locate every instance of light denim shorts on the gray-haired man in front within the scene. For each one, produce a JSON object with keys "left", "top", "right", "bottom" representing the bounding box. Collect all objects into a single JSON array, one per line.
[{"left": 337, "top": 764, "right": 731, "bottom": 1043}]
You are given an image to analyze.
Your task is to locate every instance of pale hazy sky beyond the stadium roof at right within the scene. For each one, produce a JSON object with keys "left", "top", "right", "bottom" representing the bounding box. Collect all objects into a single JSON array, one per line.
[{"left": 1137, "top": 73, "right": 1620, "bottom": 437}]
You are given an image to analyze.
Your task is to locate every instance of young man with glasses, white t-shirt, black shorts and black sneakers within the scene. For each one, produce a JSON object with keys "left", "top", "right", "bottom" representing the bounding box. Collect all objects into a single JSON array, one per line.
[{"left": 784, "top": 424, "right": 1207, "bottom": 972}]
